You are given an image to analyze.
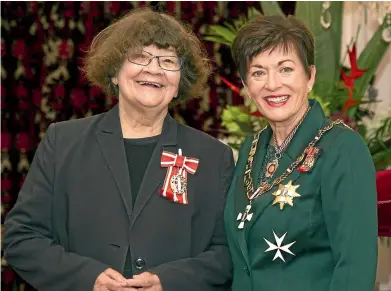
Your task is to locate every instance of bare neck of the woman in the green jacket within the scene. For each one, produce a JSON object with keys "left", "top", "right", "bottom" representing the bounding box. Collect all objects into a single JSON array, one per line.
[{"left": 269, "top": 102, "right": 309, "bottom": 146}]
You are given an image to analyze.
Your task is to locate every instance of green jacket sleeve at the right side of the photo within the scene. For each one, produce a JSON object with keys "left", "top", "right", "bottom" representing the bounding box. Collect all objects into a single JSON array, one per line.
[{"left": 321, "top": 131, "right": 377, "bottom": 291}]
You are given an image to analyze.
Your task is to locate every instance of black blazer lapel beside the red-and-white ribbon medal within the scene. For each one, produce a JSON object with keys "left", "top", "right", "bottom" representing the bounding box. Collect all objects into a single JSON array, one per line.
[{"left": 131, "top": 114, "right": 178, "bottom": 227}]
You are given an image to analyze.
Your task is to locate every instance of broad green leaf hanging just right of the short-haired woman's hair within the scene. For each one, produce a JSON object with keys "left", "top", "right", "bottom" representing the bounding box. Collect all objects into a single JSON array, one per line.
[{"left": 296, "top": 1, "right": 341, "bottom": 96}]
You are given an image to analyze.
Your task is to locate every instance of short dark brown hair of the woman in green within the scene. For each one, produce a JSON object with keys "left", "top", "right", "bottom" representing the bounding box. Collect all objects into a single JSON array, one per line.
[{"left": 231, "top": 15, "right": 315, "bottom": 82}]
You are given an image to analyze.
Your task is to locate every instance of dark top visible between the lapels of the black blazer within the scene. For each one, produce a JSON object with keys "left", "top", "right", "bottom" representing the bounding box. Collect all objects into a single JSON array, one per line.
[{"left": 124, "top": 135, "right": 160, "bottom": 206}]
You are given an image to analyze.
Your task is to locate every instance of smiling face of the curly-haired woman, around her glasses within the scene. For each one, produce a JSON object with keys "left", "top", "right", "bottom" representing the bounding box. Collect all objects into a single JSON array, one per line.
[{"left": 112, "top": 45, "right": 181, "bottom": 111}]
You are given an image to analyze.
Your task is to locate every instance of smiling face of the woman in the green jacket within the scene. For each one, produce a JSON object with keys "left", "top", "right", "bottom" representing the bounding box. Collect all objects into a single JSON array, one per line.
[{"left": 244, "top": 47, "right": 316, "bottom": 124}]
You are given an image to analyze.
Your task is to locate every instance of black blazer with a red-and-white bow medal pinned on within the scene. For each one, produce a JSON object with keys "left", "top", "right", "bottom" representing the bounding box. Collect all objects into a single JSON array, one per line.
[{"left": 4, "top": 106, "right": 234, "bottom": 291}]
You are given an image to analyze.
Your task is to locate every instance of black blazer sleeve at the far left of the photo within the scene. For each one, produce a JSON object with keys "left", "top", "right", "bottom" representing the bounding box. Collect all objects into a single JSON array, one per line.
[{"left": 4, "top": 124, "right": 109, "bottom": 291}]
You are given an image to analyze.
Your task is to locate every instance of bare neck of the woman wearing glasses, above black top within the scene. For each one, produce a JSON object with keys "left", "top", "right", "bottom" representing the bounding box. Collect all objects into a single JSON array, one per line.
[{"left": 118, "top": 98, "right": 168, "bottom": 138}]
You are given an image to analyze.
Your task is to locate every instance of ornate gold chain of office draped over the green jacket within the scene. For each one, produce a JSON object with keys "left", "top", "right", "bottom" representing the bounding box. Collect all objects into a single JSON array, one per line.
[{"left": 244, "top": 119, "right": 351, "bottom": 203}]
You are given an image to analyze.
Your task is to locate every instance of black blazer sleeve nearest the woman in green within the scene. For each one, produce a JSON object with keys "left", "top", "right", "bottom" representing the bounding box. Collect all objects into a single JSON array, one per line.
[{"left": 150, "top": 148, "right": 234, "bottom": 291}]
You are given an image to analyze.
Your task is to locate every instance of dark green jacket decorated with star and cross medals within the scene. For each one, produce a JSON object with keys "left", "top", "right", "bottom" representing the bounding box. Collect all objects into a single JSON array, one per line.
[{"left": 225, "top": 100, "right": 377, "bottom": 291}]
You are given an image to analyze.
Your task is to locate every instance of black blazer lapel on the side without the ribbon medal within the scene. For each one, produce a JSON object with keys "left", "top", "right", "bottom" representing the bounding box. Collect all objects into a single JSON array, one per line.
[{"left": 96, "top": 105, "right": 133, "bottom": 219}]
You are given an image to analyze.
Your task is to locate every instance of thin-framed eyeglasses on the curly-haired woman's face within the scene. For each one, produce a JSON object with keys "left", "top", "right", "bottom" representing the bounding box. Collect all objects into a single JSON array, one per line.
[{"left": 128, "top": 51, "right": 183, "bottom": 72}]
